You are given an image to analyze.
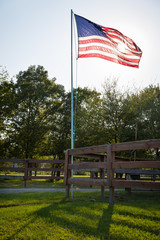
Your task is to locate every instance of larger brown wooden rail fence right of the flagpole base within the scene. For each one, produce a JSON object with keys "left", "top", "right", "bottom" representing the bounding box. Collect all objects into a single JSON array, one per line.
[{"left": 64, "top": 139, "right": 160, "bottom": 205}]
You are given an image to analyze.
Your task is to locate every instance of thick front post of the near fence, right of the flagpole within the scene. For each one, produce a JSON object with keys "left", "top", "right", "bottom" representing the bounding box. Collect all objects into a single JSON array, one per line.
[{"left": 107, "top": 144, "right": 115, "bottom": 205}]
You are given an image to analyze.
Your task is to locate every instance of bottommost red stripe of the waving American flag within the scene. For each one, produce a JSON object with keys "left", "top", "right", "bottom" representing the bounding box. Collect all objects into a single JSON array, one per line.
[{"left": 78, "top": 53, "right": 138, "bottom": 68}]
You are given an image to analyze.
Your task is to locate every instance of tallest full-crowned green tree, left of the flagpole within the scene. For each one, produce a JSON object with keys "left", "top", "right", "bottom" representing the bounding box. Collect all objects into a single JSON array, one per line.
[{"left": 8, "top": 66, "right": 63, "bottom": 158}]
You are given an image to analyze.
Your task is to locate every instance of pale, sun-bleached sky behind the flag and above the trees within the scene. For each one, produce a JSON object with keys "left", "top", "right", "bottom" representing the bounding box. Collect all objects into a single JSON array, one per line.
[{"left": 0, "top": 0, "right": 160, "bottom": 91}]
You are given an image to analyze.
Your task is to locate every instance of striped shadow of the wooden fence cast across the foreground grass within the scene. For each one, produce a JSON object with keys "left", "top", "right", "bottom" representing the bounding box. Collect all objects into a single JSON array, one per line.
[{"left": 8, "top": 193, "right": 160, "bottom": 240}]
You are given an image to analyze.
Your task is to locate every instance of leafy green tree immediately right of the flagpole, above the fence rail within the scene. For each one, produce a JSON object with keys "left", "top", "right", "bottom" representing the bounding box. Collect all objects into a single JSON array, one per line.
[{"left": 75, "top": 88, "right": 106, "bottom": 147}]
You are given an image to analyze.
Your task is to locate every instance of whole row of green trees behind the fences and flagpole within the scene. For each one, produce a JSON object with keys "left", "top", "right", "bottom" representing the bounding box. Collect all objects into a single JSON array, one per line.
[{"left": 0, "top": 66, "right": 160, "bottom": 159}]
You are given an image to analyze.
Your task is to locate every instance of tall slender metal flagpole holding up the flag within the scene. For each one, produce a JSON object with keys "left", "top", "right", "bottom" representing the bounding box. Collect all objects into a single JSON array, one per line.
[{"left": 71, "top": 9, "right": 74, "bottom": 198}]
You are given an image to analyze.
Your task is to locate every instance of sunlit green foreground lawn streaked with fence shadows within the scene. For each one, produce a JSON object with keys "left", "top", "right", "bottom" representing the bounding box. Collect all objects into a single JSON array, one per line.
[{"left": 0, "top": 191, "right": 160, "bottom": 240}]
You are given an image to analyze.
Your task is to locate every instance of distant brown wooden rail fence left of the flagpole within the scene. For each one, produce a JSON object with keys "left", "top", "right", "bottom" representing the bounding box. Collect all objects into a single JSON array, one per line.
[{"left": 0, "top": 159, "right": 65, "bottom": 187}]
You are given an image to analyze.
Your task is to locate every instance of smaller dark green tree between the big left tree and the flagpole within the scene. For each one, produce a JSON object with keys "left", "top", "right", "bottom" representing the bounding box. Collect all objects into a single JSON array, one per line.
[{"left": 42, "top": 88, "right": 71, "bottom": 159}]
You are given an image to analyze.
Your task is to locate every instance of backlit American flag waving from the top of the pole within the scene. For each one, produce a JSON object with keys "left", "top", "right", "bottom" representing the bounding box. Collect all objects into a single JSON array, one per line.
[{"left": 75, "top": 14, "right": 142, "bottom": 68}]
